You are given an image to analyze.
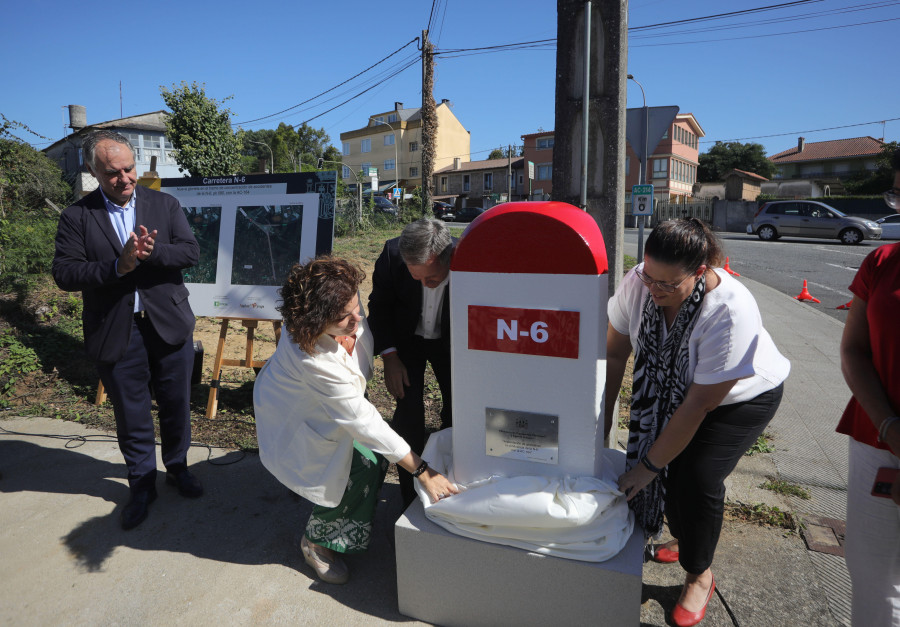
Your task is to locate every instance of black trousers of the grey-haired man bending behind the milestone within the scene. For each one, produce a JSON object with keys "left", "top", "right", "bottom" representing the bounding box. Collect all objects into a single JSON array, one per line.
[{"left": 391, "top": 335, "right": 453, "bottom": 508}]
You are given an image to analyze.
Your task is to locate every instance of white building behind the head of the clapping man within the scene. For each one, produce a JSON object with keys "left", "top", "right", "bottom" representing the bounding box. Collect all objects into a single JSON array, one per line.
[{"left": 43, "top": 105, "right": 187, "bottom": 197}]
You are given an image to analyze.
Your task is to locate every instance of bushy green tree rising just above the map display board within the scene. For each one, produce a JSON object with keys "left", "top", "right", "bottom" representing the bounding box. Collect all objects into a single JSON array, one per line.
[{"left": 159, "top": 81, "right": 243, "bottom": 176}]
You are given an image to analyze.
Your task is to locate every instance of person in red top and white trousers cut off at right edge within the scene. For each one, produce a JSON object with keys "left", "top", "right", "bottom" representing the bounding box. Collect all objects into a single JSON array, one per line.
[{"left": 837, "top": 150, "right": 900, "bottom": 626}]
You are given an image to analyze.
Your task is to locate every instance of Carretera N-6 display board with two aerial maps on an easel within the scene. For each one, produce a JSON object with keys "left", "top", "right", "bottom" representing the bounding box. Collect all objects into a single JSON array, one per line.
[{"left": 161, "top": 172, "right": 337, "bottom": 320}]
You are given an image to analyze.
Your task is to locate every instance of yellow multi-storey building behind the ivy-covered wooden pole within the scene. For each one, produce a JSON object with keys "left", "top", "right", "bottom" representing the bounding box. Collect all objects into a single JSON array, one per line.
[{"left": 341, "top": 100, "right": 470, "bottom": 191}]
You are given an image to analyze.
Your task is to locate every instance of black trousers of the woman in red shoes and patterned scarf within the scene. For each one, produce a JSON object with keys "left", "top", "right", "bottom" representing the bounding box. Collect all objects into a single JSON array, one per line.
[{"left": 665, "top": 384, "right": 784, "bottom": 575}]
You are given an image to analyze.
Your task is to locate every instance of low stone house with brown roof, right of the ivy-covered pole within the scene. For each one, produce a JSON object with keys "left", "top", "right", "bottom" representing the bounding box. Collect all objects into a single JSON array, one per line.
[{"left": 434, "top": 157, "right": 527, "bottom": 209}]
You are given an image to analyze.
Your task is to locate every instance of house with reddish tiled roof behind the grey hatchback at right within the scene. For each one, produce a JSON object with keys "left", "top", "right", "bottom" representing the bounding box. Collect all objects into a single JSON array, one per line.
[{"left": 763, "top": 137, "right": 884, "bottom": 196}]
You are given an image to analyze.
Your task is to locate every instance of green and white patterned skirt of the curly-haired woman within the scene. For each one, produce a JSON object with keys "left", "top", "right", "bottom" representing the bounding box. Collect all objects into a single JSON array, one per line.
[{"left": 306, "top": 441, "right": 388, "bottom": 553}]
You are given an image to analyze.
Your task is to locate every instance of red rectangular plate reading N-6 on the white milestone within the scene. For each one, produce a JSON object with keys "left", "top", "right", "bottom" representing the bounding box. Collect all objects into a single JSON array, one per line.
[{"left": 468, "top": 305, "right": 580, "bottom": 359}]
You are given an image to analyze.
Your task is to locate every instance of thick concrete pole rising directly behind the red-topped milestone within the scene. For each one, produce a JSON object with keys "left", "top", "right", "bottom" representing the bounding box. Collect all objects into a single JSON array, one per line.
[{"left": 553, "top": 0, "right": 628, "bottom": 295}]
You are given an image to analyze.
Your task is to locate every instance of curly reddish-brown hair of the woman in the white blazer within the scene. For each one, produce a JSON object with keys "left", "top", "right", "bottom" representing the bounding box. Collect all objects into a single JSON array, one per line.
[{"left": 276, "top": 255, "right": 366, "bottom": 355}]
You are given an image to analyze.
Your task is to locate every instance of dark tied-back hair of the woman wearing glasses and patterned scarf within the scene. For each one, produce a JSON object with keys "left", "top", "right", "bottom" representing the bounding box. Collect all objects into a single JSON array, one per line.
[{"left": 644, "top": 218, "right": 725, "bottom": 272}]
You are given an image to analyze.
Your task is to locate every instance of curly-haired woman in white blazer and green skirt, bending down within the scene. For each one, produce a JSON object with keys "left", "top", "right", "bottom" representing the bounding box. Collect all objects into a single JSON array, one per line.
[{"left": 253, "top": 257, "right": 457, "bottom": 584}]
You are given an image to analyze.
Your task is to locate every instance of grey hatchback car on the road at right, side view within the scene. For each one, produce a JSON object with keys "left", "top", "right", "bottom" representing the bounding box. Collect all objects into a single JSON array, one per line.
[{"left": 747, "top": 200, "right": 881, "bottom": 244}]
